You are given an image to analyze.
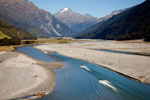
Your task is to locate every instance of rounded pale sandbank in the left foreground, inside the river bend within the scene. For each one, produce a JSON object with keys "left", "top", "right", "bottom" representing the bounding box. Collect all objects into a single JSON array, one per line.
[{"left": 0, "top": 51, "right": 63, "bottom": 100}]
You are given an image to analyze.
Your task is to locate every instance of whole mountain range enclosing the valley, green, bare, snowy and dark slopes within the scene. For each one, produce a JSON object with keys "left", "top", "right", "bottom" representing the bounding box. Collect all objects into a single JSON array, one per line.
[{"left": 0, "top": 0, "right": 150, "bottom": 40}]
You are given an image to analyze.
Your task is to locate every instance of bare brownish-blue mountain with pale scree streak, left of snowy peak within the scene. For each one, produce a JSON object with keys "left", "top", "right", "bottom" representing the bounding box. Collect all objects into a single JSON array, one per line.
[{"left": 0, "top": 0, "right": 73, "bottom": 37}]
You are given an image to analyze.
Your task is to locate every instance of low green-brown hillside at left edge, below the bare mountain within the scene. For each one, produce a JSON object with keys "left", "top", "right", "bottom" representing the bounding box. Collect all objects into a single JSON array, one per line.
[{"left": 0, "top": 18, "right": 34, "bottom": 39}]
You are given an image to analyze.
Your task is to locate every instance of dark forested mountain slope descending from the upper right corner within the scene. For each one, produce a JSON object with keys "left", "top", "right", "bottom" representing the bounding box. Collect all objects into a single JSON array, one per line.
[{"left": 77, "top": 0, "right": 150, "bottom": 40}]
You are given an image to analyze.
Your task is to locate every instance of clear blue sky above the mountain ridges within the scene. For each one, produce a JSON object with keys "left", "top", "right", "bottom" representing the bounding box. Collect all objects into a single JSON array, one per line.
[{"left": 29, "top": 0, "right": 144, "bottom": 17}]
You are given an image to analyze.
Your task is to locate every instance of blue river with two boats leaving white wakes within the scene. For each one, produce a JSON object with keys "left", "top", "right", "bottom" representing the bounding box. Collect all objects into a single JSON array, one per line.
[{"left": 16, "top": 46, "right": 150, "bottom": 100}]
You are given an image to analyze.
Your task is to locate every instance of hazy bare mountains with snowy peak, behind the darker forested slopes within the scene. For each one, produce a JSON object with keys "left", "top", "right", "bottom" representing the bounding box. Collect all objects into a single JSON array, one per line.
[{"left": 0, "top": 0, "right": 129, "bottom": 38}]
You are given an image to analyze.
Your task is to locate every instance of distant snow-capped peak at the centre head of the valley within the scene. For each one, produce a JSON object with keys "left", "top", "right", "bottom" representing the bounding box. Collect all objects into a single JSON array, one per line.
[{"left": 54, "top": 8, "right": 98, "bottom": 32}]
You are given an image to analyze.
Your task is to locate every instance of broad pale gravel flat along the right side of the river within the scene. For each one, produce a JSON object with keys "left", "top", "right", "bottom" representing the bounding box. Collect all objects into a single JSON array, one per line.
[{"left": 35, "top": 40, "right": 150, "bottom": 83}]
